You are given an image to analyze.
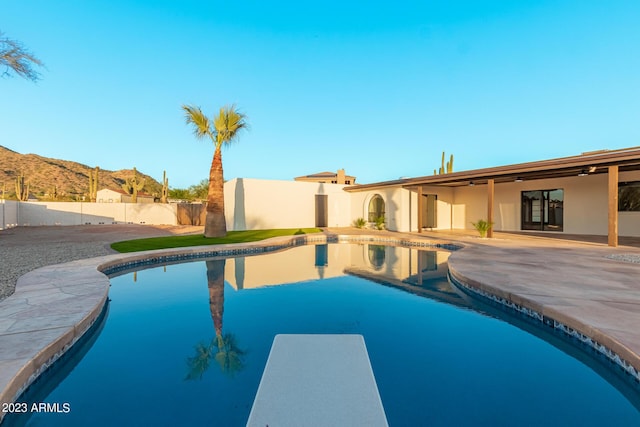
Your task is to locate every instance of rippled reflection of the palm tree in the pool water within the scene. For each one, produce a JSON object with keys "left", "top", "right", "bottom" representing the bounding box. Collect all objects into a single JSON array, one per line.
[{"left": 185, "top": 259, "right": 245, "bottom": 380}]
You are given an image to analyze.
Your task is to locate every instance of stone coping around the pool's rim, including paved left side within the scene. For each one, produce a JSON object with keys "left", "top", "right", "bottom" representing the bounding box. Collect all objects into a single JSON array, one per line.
[{"left": 0, "top": 234, "right": 640, "bottom": 422}]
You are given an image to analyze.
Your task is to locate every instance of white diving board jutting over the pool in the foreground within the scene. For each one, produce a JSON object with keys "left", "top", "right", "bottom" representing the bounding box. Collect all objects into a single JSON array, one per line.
[{"left": 247, "top": 335, "right": 388, "bottom": 427}]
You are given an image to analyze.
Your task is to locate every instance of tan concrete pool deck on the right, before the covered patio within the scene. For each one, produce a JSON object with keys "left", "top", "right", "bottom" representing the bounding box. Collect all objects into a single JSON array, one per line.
[{"left": 449, "top": 231, "right": 640, "bottom": 380}]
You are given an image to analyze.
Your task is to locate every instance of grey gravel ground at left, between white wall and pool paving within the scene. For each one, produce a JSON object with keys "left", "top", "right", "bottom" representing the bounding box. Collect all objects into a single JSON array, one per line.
[{"left": 0, "top": 224, "right": 203, "bottom": 300}]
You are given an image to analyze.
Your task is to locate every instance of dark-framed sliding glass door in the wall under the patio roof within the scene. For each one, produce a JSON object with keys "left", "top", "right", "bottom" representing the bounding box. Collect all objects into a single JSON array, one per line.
[{"left": 522, "top": 189, "right": 564, "bottom": 231}]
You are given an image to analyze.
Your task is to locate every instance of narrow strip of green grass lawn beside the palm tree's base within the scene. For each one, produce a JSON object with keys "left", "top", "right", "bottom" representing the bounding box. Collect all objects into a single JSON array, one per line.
[{"left": 111, "top": 228, "right": 322, "bottom": 252}]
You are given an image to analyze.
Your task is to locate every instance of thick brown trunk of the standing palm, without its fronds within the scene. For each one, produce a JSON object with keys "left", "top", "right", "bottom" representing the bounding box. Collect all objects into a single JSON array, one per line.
[{"left": 204, "top": 147, "right": 227, "bottom": 237}]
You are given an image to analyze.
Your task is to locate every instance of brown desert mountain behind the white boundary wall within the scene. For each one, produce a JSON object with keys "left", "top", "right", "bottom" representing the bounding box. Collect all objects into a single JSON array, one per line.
[{"left": 0, "top": 145, "right": 162, "bottom": 201}]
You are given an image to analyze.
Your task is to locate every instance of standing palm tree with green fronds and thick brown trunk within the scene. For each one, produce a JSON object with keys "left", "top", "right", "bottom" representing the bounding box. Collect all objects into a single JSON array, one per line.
[{"left": 182, "top": 105, "right": 247, "bottom": 237}]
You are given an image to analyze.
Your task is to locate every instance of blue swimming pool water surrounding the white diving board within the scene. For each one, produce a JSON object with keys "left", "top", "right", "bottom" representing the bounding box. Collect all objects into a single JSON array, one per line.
[{"left": 3, "top": 244, "right": 640, "bottom": 426}]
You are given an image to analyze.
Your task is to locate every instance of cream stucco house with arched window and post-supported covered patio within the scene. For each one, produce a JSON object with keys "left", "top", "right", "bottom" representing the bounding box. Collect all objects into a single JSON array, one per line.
[{"left": 225, "top": 147, "right": 640, "bottom": 246}]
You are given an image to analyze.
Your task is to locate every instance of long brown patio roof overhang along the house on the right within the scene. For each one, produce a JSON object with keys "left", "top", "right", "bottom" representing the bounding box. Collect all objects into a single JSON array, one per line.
[{"left": 345, "top": 147, "right": 640, "bottom": 192}]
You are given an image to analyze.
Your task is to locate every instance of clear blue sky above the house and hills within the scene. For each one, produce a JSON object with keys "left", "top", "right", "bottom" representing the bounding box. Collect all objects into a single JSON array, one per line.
[{"left": 0, "top": 0, "right": 640, "bottom": 187}]
